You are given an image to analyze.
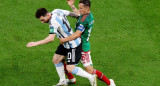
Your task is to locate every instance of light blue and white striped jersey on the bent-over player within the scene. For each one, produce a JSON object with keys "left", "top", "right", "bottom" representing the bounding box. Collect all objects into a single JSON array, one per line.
[{"left": 49, "top": 9, "right": 81, "bottom": 49}]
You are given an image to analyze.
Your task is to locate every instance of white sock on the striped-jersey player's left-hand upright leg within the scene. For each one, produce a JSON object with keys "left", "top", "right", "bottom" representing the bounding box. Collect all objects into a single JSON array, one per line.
[{"left": 55, "top": 62, "right": 65, "bottom": 81}]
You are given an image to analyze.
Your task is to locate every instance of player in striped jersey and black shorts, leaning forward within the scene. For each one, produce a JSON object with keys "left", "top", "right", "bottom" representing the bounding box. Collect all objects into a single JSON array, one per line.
[{"left": 27, "top": 8, "right": 96, "bottom": 86}]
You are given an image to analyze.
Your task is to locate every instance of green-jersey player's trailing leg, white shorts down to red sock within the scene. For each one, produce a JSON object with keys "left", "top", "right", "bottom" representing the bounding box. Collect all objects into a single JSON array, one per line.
[{"left": 81, "top": 51, "right": 113, "bottom": 85}]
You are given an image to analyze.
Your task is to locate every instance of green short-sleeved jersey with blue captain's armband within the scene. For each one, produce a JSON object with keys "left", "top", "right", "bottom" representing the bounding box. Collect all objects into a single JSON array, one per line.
[{"left": 76, "top": 13, "right": 94, "bottom": 52}]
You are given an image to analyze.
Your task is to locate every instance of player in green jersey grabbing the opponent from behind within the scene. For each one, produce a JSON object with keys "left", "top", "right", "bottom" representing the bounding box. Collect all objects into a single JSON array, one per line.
[{"left": 60, "top": 0, "right": 116, "bottom": 86}]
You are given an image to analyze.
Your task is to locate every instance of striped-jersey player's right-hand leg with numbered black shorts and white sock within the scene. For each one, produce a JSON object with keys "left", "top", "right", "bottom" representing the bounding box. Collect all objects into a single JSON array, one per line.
[{"left": 67, "top": 45, "right": 97, "bottom": 86}]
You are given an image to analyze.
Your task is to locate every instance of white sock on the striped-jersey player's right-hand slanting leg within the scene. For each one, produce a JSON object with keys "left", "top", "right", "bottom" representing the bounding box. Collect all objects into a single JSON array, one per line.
[{"left": 72, "top": 67, "right": 93, "bottom": 80}]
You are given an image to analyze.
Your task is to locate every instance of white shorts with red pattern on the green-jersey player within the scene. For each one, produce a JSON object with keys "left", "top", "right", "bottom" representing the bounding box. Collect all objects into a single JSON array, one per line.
[{"left": 81, "top": 51, "right": 93, "bottom": 67}]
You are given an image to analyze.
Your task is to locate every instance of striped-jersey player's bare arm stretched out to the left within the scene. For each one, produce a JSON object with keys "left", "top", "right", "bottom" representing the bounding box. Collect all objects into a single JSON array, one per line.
[{"left": 27, "top": 34, "right": 56, "bottom": 47}]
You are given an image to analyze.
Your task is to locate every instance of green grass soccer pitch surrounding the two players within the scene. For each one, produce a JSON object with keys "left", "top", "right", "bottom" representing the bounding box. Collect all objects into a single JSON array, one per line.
[{"left": 0, "top": 0, "right": 160, "bottom": 86}]
